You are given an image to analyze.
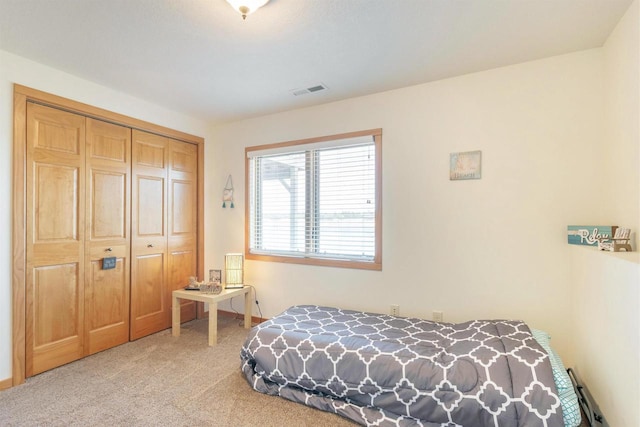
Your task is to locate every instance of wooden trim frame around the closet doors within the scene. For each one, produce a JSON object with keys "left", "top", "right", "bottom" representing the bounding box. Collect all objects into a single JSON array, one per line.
[{"left": 11, "top": 84, "right": 204, "bottom": 386}]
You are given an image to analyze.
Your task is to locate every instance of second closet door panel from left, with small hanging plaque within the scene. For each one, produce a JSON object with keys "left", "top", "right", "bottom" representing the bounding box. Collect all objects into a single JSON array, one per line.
[{"left": 84, "top": 118, "right": 131, "bottom": 355}]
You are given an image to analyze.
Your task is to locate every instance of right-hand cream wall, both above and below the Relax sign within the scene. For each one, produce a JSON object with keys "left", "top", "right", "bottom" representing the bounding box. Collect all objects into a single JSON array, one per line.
[{"left": 570, "top": 1, "right": 640, "bottom": 426}]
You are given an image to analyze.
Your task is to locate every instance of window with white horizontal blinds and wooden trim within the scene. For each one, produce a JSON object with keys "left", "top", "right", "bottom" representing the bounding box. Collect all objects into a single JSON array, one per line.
[{"left": 246, "top": 129, "right": 382, "bottom": 270}]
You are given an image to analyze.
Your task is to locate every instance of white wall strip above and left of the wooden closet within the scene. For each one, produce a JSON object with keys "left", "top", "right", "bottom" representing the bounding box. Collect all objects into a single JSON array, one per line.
[{"left": 0, "top": 51, "right": 215, "bottom": 381}]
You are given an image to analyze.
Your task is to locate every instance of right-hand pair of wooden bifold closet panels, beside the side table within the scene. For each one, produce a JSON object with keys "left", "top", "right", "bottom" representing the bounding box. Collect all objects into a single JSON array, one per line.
[{"left": 130, "top": 130, "right": 198, "bottom": 339}]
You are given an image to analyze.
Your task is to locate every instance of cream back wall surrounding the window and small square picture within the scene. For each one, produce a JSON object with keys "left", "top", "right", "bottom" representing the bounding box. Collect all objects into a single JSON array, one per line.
[{"left": 207, "top": 49, "right": 608, "bottom": 360}]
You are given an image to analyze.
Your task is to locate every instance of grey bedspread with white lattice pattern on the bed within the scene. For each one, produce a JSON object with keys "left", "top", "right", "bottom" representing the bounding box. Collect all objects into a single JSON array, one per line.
[{"left": 240, "top": 305, "right": 564, "bottom": 427}]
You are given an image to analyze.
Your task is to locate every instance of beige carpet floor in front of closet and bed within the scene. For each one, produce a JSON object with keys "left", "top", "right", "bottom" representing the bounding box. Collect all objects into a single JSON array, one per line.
[{"left": 0, "top": 316, "right": 355, "bottom": 427}]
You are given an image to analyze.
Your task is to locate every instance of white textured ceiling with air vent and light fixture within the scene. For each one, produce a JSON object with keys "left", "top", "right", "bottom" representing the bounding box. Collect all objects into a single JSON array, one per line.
[{"left": 0, "top": 0, "right": 632, "bottom": 122}]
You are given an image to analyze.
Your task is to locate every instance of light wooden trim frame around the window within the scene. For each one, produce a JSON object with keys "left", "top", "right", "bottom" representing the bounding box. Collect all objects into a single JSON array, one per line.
[{"left": 244, "top": 129, "right": 382, "bottom": 271}]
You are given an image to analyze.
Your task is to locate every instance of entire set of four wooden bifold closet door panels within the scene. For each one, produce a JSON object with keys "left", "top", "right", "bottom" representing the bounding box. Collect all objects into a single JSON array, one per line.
[{"left": 20, "top": 90, "right": 202, "bottom": 379}]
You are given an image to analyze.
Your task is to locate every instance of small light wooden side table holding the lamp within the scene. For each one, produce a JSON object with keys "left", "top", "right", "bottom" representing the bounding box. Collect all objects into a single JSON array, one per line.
[{"left": 171, "top": 286, "right": 251, "bottom": 346}]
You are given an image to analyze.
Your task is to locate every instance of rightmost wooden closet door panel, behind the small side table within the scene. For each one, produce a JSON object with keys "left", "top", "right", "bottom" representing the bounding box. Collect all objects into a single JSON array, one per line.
[{"left": 167, "top": 140, "right": 199, "bottom": 322}]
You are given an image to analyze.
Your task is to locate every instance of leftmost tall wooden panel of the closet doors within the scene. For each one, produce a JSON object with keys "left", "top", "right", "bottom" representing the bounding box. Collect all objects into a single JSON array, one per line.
[{"left": 25, "top": 103, "right": 85, "bottom": 376}]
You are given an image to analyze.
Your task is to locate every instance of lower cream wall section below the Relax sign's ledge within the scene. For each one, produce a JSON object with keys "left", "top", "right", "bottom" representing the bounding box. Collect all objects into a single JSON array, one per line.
[{"left": 571, "top": 247, "right": 640, "bottom": 427}]
